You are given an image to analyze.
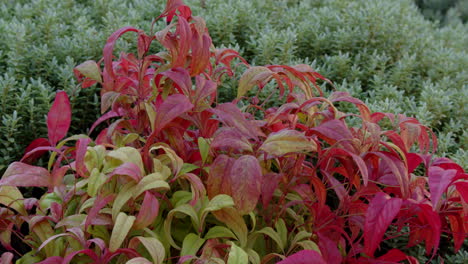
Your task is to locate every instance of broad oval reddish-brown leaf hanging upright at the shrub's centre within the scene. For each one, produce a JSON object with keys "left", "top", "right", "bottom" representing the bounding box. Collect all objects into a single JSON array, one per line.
[{"left": 229, "top": 155, "right": 262, "bottom": 215}]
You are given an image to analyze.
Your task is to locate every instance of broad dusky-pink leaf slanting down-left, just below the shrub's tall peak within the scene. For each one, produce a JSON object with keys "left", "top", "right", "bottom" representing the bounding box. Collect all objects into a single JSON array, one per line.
[{"left": 154, "top": 94, "right": 193, "bottom": 131}]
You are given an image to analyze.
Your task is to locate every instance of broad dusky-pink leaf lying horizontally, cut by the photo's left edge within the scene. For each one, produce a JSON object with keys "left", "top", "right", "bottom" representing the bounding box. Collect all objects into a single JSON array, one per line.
[{"left": 0, "top": 162, "right": 51, "bottom": 187}]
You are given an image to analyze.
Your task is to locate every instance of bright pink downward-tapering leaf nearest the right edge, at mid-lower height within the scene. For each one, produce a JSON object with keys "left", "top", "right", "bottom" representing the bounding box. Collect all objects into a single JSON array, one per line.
[{"left": 428, "top": 166, "right": 457, "bottom": 210}]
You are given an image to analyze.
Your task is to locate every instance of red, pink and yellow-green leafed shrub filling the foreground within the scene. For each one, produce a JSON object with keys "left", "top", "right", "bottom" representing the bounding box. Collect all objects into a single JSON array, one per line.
[{"left": 0, "top": 0, "right": 468, "bottom": 264}]
